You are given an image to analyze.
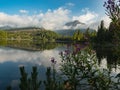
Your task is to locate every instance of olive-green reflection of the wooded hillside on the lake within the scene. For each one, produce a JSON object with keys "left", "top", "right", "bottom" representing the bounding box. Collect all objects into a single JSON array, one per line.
[{"left": 0, "top": 40, "right": 62, "bottom": 51}]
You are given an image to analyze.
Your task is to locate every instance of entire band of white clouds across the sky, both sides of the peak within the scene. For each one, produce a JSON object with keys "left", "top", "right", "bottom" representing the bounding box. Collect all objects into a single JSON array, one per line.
[{"left": 0, "top": 7, "right": 110, "bottom": 30}]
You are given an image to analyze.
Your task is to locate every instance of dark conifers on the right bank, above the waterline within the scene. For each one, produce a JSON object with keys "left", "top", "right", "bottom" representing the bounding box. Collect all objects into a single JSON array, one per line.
[{"left": 95, "top": 21, "right": 120, "bottom": 45}]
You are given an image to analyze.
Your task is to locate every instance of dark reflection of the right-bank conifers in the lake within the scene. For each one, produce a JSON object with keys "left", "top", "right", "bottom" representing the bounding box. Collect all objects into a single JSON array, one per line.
[{"left": 94, "top": 45, "right": 120, "bottom": 72}]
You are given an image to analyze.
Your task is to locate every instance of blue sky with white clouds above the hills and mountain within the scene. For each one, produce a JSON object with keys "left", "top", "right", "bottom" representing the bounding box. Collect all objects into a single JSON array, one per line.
[{"left": 0, "top": 0, "right": 110, "bottom": 30}]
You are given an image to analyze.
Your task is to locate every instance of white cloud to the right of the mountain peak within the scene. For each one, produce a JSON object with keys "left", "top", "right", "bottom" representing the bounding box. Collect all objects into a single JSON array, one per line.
[{"left": 72, "top": 8, "right": 111, "bottom": 30}]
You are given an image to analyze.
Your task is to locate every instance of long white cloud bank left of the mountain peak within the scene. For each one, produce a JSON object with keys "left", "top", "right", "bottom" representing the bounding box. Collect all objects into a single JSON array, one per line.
[{"left": 0, "top": 8, "right": 70, "bottom": 30}]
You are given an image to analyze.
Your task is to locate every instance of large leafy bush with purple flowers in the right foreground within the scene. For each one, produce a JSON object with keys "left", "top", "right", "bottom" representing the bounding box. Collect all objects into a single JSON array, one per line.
[{"left": 61, "top": 45, "right": 120, "bottom": 90}]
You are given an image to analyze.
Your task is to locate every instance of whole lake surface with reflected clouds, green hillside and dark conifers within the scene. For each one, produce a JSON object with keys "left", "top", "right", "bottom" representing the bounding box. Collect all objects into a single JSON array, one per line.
[{"left": 0, "top": 42, "right": 120, "bottom": 90}]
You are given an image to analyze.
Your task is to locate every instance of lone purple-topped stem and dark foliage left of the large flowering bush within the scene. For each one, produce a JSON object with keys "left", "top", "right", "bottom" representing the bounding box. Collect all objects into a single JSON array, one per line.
[{"left": 44, "top": 58, "right": 63, "bottom": 90}]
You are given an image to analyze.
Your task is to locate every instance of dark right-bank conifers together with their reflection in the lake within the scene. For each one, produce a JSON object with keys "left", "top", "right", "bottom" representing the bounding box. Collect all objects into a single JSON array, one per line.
[{"left": 92, "top": 21, "right": 120, "bottom": 68}]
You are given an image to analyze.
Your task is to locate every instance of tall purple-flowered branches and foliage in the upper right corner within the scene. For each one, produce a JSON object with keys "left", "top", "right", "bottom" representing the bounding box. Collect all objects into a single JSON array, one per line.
[{"left": 101, "top": 0, "right": 120, "bottom": 45}]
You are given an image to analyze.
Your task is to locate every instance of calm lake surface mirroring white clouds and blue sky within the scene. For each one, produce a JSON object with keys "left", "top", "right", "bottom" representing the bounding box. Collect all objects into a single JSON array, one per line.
[{"left": 0, "top": 42, "right": 120, "bottom": 90}]
